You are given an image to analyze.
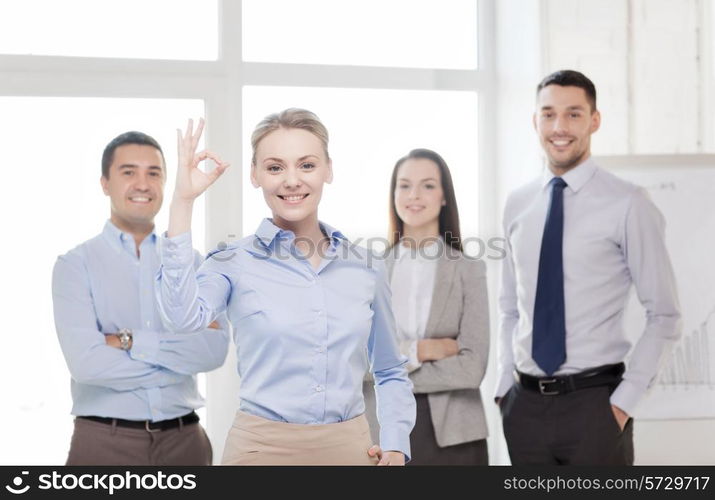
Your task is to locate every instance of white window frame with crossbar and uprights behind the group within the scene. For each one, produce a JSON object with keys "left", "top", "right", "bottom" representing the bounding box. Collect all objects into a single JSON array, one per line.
[{"left": 0, "top": 0, "right": 499, "bottom": 460}]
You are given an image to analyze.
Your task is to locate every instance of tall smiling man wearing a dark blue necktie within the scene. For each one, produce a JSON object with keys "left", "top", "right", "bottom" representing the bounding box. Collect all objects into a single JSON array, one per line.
[{"left": 495, "top": 70, "right": 680, "bottom": 465}]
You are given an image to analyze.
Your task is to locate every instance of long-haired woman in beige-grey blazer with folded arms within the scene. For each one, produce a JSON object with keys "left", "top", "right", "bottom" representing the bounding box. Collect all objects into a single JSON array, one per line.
[{"left": 364, "top": 149, "right": 489, "bottom": 465}]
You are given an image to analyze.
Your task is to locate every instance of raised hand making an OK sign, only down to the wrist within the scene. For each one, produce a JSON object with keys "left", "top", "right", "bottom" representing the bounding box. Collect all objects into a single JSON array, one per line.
[{"left": 174, "top": 118, "right": 228, "bottom": 203}]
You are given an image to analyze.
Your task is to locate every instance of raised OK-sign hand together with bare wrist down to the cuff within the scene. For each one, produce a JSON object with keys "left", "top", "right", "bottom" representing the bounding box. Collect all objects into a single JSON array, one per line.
[{"left": 167, "top": 118, "right": 228, "bottom": 238}]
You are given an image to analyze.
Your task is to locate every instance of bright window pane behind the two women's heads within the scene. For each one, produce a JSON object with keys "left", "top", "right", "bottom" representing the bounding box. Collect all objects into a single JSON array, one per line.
[{"left": 243, "top": 87, "right": 479, "bottom": 246}]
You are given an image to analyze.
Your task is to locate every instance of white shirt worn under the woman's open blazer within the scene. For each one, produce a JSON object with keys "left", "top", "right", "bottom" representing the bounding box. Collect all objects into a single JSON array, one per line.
[{"left": 390, "top": 242, "right": 440, "bottom": 372}]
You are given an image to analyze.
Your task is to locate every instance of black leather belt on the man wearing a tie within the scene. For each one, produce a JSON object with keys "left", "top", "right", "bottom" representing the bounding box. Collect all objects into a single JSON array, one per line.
[{"left": 514, "top": 363, "right": 626, "bottom": 396}]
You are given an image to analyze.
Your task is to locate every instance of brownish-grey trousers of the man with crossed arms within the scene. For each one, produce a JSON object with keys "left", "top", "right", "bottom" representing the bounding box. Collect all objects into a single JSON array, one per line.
[{"left": 66, "top": 418, "right": 213, "bottom": 466}]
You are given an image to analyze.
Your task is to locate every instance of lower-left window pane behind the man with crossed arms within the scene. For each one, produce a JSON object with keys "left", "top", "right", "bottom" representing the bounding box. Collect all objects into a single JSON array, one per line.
[{"left": 0, "top": 97, "right": 204, "bottom": 464}]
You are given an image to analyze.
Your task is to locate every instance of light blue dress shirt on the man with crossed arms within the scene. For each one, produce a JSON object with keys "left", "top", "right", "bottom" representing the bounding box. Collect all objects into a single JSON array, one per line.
[{"left": 52, "top": 221, "right": 229, "bottom": 421}]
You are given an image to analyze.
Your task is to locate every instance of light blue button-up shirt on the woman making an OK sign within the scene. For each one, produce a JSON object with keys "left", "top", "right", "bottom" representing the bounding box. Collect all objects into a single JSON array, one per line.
[{"left": 157, "top": 219, "right": 415, "bottom": 457}]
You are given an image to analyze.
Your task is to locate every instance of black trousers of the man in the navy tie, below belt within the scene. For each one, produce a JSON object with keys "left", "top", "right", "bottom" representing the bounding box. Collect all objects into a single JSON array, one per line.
[{"left": 499, "top": 383, "right": 633, "bottom": 465}]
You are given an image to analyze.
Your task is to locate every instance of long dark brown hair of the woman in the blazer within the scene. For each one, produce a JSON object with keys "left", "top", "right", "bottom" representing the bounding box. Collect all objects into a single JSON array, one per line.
[{"left": 387, "top": 149, "right": 462, "bottom": 252}]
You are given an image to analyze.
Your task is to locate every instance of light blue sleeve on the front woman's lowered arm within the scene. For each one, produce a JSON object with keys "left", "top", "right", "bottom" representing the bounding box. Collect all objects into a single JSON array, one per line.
[{"left": 368, "top": 260, "right": 416, "bottom": 460}]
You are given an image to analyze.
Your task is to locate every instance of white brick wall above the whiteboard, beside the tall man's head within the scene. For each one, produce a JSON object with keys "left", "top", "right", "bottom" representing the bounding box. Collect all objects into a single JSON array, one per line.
[{"left": 541, "top": 0, "right": 715, "bottom": 155}]
